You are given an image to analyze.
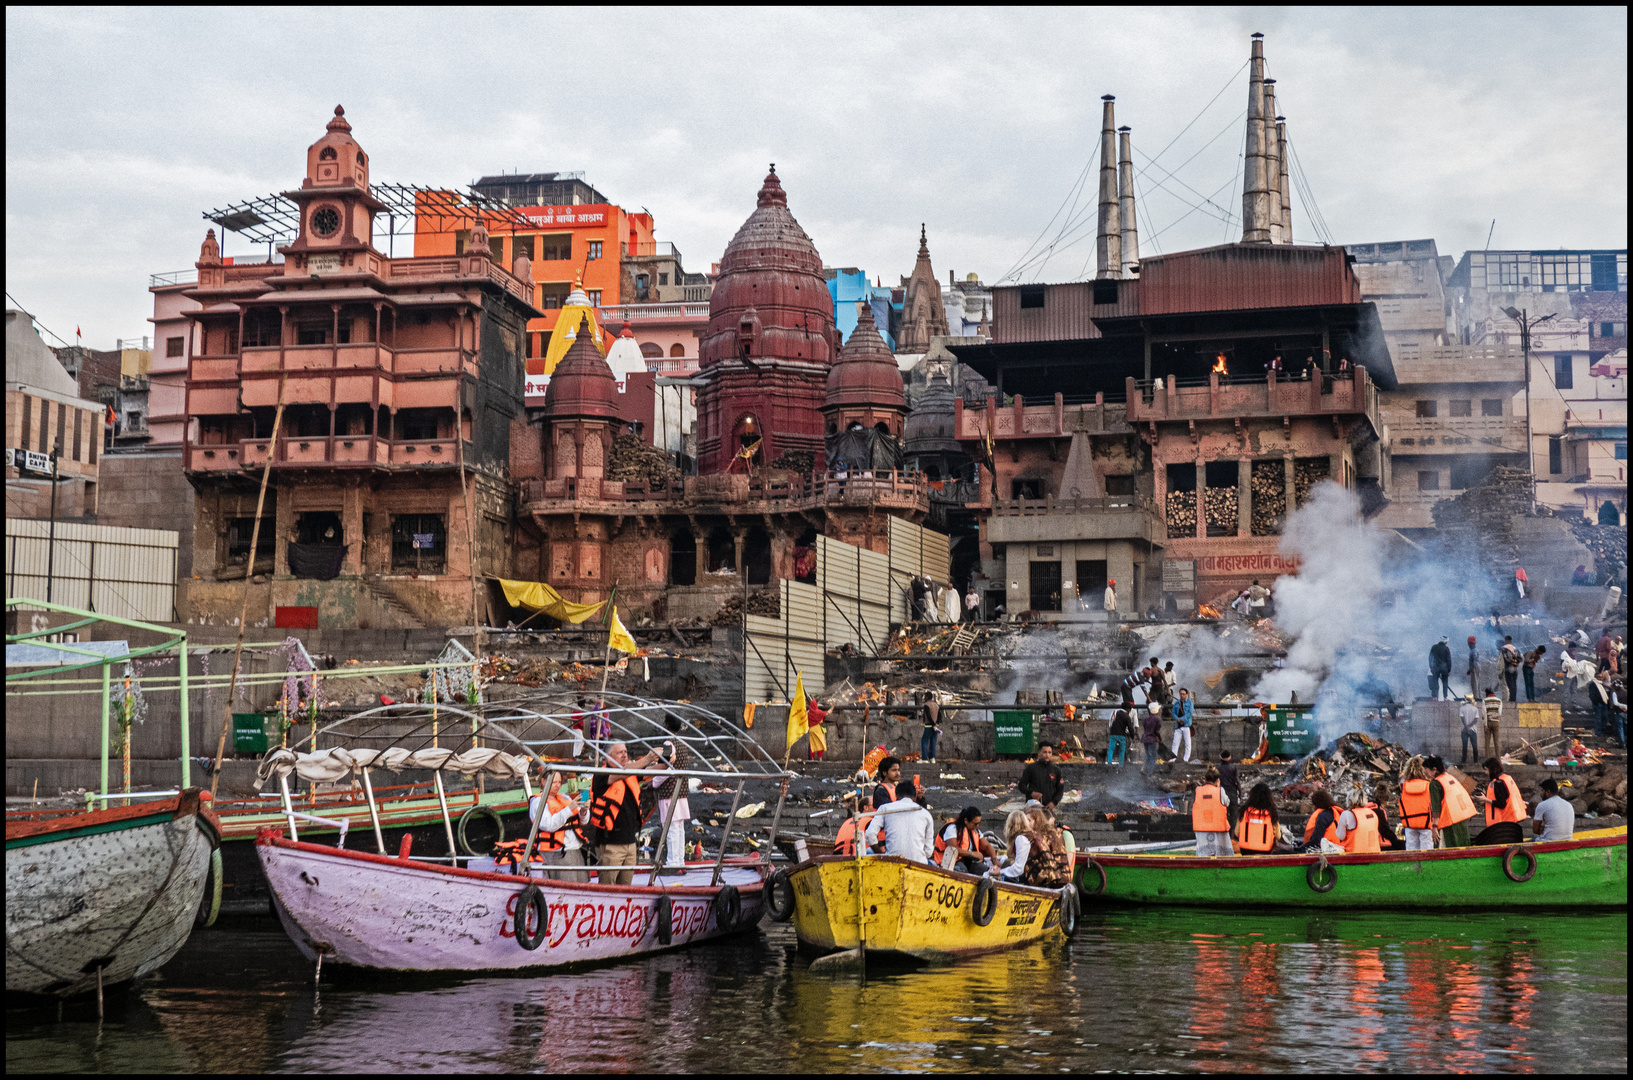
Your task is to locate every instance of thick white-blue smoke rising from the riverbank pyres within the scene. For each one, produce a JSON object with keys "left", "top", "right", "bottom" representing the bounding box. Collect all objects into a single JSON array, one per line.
[{"left": 1251, "top": 482, "right": 1501, "bottom": 740}]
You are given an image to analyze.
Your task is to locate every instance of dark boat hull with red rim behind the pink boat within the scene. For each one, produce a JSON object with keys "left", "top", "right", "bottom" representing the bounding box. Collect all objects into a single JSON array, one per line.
[{"left": 220, "top": 789, "right": 527, "bottom": 915}]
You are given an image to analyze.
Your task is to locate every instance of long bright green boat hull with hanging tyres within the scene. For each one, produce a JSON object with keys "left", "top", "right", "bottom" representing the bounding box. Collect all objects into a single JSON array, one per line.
[{"left": 1076, "top": 827, "right": 1628, "bottom": 910}]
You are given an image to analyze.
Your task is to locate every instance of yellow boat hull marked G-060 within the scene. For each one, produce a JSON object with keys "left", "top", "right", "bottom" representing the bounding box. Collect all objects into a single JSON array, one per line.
[{"left": 789, "top": 855, "right": 1061, "bottom": 961}]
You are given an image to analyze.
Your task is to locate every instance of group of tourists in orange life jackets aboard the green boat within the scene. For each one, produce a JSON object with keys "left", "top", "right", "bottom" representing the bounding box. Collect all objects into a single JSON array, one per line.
[{"left": 1190, "top": 752, "right": 1576, "bottom": 856}]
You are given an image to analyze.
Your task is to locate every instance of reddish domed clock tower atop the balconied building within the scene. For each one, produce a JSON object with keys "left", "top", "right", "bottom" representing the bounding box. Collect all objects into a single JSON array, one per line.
[{"left": 283, "top": 105, "right": 385, "bottom": 263}]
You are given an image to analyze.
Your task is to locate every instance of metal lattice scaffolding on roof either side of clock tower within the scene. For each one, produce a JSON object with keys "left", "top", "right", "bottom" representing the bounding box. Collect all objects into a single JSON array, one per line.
[{"left": 202, "top": 183, "right": 537, "bottom": 245}]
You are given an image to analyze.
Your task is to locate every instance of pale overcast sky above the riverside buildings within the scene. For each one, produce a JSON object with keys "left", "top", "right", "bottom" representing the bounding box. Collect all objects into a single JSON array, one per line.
[{"left": 7, "top": 7, "right": 1628, "bottom": 348}]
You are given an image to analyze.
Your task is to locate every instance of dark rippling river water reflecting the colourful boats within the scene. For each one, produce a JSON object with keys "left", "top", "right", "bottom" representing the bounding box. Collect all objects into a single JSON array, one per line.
[{"left": 7, "top": 908, "right": 1628, "bottom": 1073}]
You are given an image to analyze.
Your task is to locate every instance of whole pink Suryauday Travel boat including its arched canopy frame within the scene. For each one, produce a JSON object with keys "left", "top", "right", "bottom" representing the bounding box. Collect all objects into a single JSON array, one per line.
[{"left": 255, "top": 694, "right": 787, "bottom": 972}]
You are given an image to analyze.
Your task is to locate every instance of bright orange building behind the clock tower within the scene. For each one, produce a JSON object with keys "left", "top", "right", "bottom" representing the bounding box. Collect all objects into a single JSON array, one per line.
[{"left": 413, "top": 191, "right": 653, "bottom": 374}]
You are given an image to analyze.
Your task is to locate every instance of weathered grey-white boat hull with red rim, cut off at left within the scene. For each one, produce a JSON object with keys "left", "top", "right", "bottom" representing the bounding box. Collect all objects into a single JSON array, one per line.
[{"left": 5, "top": 788, "right": 219, "bottom": 998}]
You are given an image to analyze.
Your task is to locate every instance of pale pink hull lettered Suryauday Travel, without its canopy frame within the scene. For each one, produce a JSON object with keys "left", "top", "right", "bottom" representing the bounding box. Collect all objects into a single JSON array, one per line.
[{"left": 256, "top": 832, "right": 764, "bottom": 972}]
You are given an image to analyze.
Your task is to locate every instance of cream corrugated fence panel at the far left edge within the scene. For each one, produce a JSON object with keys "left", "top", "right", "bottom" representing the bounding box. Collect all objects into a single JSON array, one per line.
[{"left": 5, "top": 518, "right": 178, "bottom": 623}]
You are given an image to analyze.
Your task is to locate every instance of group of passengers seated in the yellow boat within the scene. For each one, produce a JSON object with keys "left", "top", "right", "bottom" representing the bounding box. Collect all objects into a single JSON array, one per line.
[{"left": 833, "top": 758, "right": 1073, "bottom": 889}]
